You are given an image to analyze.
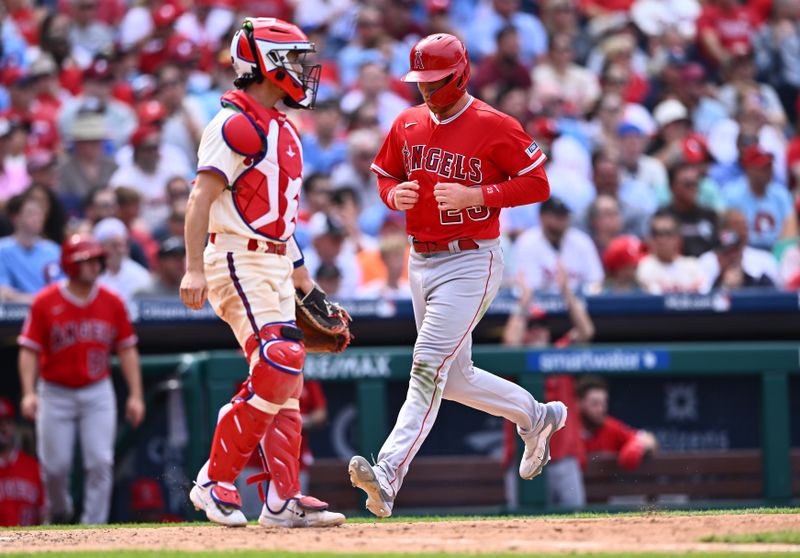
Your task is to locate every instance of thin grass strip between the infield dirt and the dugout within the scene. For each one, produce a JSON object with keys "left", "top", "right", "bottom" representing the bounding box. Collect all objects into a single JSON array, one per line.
[{"left": 0, "top": 507, "right": 800, "bottom": 533}]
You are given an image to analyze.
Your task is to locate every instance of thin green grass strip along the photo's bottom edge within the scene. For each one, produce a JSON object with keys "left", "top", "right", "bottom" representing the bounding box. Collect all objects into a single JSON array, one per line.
[{"left": 3, "top": 550, "right": 800, "bottom": 558}]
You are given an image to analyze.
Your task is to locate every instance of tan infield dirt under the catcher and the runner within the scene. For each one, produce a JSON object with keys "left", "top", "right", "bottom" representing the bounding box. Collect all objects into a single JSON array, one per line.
[{"left": 0, "top": 514, "right": 800, "bottom": 554}]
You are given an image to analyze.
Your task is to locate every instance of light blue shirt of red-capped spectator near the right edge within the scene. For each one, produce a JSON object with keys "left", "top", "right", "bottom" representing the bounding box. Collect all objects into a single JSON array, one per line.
[{"left": 722, "top": 177, "right": 793, "bottom": 250}]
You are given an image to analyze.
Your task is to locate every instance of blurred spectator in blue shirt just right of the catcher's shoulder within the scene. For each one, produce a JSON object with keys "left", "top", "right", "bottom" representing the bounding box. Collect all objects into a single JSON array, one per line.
[{"left": 300, "top": 99, "right": 347, "bottom": 175}]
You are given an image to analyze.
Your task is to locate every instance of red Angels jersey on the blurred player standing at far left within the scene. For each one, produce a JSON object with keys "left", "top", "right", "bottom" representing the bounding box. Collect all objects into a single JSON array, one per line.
[{"left": 18, "top": 283, "right": 137, "bottom": 388}]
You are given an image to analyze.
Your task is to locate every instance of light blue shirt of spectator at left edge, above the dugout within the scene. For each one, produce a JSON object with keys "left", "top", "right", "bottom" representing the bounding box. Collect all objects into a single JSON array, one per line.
[{"left": 0, "top": 236, "right": 61, "bottom": 294}]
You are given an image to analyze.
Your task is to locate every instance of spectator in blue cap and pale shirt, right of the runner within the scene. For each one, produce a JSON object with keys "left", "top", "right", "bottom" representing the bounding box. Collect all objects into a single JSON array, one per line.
[{"left": 617, "top": 122, "right": 669, "bottom": 213}]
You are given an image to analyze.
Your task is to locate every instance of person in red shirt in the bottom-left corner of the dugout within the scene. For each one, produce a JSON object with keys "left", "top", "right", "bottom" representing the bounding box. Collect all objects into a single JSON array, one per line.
[{"left": 0, "top": 398, "right": 45, "bottom": 527}]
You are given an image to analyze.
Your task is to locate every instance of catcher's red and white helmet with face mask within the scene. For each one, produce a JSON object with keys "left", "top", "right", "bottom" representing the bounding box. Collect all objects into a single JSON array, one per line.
[{"left": 231, "top": 17, "right": 322, "bottom": 109}]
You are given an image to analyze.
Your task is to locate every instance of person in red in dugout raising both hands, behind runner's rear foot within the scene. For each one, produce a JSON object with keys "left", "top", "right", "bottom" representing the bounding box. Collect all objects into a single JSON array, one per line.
[{"left": 503, "top": 264, "right": 594, "bottom": 508}]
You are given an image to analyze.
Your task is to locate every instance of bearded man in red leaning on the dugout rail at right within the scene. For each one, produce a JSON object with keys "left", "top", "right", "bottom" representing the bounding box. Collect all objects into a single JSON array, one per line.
[{"left": 577, "top": 376, "right": 658, "bottom": 471}]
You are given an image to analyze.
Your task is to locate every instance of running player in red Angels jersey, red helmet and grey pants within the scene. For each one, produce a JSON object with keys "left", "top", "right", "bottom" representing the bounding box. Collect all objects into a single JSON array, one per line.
[{"left": 349, "top": 33, "right": 567, "bottom": 517}]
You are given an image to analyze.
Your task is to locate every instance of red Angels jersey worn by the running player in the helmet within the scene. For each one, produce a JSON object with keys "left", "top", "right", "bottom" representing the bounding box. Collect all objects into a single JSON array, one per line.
[{"left": 372, "top": 98, "right": 547, "bottom": 242}]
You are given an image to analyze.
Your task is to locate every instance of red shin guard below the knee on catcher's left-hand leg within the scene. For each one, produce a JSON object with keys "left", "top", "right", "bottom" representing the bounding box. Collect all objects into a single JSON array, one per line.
[{"left": 208, "top": 401, "right": 275, "bottom": 483}]
